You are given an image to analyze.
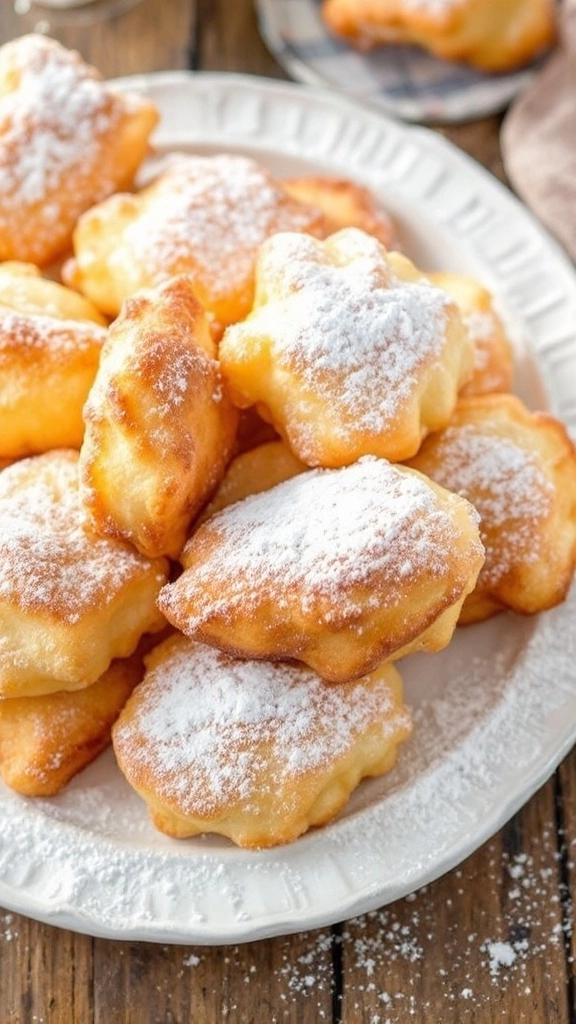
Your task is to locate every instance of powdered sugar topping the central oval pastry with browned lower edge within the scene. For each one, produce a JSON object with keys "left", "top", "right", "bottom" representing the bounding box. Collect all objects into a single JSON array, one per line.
[{"left": 162, "top": 457, "right": 471, "bottom": 627}]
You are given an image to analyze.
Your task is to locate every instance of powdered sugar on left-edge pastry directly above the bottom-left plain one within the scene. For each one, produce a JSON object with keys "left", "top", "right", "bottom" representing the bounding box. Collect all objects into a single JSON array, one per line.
[{"left": 0, "top": 453, "right": 161, "bottom": 624}]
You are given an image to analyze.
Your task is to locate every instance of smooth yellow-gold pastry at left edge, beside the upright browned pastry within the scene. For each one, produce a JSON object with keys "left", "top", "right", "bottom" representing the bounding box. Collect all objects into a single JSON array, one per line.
[{"left": 0, "top": 262, "right": 107, "bottom": 458}]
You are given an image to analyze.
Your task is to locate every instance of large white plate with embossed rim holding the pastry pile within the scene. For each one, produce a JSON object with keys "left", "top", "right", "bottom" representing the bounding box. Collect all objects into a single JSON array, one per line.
[{"left": 0, "top": 73, "right": 576, "bottom": 944}]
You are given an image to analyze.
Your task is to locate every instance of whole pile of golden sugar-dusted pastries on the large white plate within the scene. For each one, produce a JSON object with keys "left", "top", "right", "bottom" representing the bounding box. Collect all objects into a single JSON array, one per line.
[{"left": 0, "top": 36, "right": 576, "bottom": 848}]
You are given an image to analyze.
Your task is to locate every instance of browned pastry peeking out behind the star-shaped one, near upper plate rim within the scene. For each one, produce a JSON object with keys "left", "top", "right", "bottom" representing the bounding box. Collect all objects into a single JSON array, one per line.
[{"left": 282, "top": 177, "right": 396, "bottom": 249}]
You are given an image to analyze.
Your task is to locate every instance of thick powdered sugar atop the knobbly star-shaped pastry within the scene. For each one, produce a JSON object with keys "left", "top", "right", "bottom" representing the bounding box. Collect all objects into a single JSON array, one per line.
[{"left": 230, "top": 228, "right": 451, "bottom": 436}]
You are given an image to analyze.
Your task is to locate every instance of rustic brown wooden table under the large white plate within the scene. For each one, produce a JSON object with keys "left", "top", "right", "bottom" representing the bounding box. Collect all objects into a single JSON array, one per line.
[{"left": 0, "top": 0, "right": 576, "bottom": 1024}]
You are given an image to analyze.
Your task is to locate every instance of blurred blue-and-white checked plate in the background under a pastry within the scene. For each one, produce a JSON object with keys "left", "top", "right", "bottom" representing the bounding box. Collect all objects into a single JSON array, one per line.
[{"left": 256, "top": 0, "right": 538, "bottom": 123}]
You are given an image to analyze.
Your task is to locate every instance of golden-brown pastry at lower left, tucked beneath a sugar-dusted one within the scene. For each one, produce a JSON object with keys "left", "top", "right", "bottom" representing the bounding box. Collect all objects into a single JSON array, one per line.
[{"left": 0, "top": 654, "right": 143, "bottom": 797}]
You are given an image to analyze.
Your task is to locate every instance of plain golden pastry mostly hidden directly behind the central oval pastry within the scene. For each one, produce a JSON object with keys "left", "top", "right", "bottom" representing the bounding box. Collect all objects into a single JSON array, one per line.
[{"left": 198, "top": 440, "right": 307, "bottom": 523}]
